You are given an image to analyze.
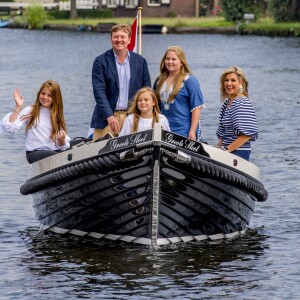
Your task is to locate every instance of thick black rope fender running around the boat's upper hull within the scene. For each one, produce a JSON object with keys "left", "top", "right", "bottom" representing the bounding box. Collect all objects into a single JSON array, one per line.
[{"left": 20, "top": 148, "right": 268, "bottom": 201}]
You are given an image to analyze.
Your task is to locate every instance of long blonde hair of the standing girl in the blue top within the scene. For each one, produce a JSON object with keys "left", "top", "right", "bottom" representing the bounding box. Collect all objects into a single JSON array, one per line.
[{"left": 156, "top": 46, "right": 191, "bottom": 102}]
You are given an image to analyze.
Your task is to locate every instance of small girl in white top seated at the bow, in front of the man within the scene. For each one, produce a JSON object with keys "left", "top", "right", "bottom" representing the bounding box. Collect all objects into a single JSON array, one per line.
[{"left": 119, "top": 87, "right": 170, "bottom": 136}]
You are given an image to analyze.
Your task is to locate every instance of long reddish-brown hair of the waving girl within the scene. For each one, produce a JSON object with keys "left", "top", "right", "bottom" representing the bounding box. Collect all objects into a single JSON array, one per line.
[{"left": 26, "top": 80, "right": 67, "bottom": 141}]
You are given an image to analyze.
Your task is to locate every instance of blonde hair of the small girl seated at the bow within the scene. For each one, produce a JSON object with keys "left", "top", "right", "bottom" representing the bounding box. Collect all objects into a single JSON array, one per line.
[{"left": 128, "top": 87, "right": 160, "bottom": 133}]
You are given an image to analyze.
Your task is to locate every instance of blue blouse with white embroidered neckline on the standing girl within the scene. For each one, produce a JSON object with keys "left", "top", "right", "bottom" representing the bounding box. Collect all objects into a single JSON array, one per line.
[{"left": 154, "top": 74, "right": 204, "bottom": 140}]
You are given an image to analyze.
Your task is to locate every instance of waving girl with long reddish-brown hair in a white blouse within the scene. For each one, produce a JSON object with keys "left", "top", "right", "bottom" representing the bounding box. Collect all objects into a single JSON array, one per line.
[{"left": 0, "top": 80, "right": 70, "bottom": 163}]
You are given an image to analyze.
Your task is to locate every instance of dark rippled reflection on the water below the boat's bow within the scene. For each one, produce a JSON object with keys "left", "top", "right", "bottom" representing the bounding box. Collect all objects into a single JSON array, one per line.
[{"left": 22, "top": 228, "right": 268, "bottom": 299}]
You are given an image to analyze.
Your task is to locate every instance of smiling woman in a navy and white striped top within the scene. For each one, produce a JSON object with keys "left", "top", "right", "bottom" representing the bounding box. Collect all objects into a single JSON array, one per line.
[{"left": 217, "top": 67, "right": 258, "bottom": 160}]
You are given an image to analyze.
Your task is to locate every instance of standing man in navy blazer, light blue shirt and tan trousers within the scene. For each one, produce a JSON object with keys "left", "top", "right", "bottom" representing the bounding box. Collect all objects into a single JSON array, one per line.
[{"left": 91, "top": 24, "right": 151, "bottom": 141}]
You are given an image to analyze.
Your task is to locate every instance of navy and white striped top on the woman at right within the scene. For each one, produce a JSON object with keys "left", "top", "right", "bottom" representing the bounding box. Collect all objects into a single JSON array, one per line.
[{"left": 216, "top": 97, "right": 258, "bottom": 150}]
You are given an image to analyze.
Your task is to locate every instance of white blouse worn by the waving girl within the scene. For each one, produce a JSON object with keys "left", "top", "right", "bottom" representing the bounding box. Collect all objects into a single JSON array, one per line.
[{"left": 0, "top": 106, "right": 70, "bottom": 151}]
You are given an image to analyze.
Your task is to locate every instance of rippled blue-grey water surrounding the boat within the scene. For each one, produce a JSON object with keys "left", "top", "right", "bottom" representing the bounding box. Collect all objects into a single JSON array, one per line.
[{"left": 0, "top": 29, "right": 300, "bottom": 300}]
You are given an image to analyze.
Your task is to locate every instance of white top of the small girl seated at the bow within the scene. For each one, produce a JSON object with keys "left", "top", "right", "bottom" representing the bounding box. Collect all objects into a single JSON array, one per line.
[{"left": 119, "top": 114, "right": 171, "bottom": 136}]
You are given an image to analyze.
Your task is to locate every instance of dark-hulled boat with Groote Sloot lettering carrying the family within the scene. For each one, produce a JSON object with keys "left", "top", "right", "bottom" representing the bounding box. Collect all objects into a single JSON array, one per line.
[{"left": 20, "top": 124, "right": 268, "bottom": 247}]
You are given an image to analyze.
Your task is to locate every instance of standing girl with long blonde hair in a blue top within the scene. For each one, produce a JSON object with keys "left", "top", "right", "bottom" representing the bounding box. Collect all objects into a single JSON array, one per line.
[{"left": 154, "top": 46, "right": 204, "bottom": 140}]
